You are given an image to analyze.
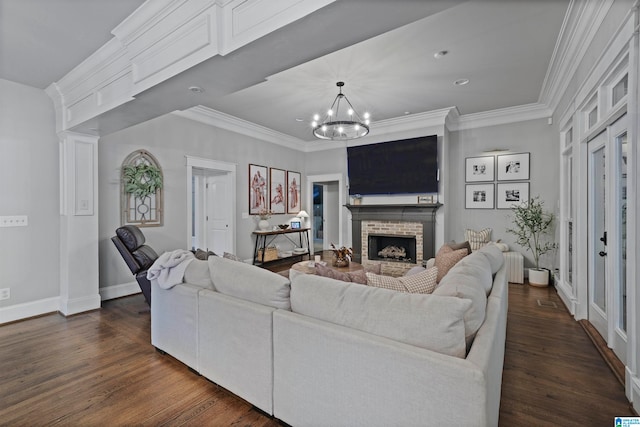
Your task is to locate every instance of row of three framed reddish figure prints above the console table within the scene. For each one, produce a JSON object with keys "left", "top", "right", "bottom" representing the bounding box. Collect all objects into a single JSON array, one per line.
[{"left": 248, "top": 164, "right": 302, "bottom": 216}]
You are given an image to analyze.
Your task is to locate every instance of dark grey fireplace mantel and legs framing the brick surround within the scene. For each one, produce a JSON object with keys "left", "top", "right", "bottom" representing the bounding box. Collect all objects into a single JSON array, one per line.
[{"left": 345, "top": 203, "right": 442, "bottom": 262}]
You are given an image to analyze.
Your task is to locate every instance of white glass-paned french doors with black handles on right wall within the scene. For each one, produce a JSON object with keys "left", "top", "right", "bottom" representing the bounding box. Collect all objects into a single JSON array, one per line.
[{"left": 588, "top": 116, "right": 627, "bottom": 363}]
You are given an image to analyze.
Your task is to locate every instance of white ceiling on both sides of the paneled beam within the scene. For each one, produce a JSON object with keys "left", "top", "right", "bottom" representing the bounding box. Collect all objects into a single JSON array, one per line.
[{"left": 0, "top": 0, "right": 569, "bottom": 140}]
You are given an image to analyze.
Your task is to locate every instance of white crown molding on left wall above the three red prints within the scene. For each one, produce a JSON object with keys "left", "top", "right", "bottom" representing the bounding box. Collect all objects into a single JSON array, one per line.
[{"left": 171, "top": 105, "right": 304, "bottom": 151}]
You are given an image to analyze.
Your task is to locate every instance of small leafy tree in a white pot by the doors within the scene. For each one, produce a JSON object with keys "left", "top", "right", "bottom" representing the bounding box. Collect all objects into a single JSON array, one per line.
[{"left": 507, "top": 196, "right": 557, "bottom": 286}]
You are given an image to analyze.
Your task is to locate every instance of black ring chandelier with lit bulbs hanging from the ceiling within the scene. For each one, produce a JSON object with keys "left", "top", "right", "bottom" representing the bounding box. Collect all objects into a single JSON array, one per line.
[{"left": 311, "top": 82, "right": 369, "bottom": 141}]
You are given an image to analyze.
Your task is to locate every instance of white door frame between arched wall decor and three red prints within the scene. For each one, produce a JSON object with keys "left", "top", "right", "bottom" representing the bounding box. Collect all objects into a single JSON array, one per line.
[{"left": 185, "top": 156, "right": 237, "bottom": 253}]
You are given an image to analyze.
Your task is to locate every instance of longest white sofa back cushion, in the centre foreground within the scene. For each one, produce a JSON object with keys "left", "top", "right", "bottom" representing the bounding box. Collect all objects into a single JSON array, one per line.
[{"left": 291, "top": 274, "right": 471, "bottom": 363}]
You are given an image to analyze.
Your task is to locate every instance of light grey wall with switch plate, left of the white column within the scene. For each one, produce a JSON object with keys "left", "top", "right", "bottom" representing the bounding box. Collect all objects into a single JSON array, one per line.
[{"left": 0, "top": 79, "right": 60, "bottom": 323}]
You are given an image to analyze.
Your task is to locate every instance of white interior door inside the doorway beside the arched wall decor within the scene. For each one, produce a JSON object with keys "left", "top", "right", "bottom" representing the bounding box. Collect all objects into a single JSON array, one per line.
[{"left": 203, "top": 174, "right": 233, "bottom": 255}]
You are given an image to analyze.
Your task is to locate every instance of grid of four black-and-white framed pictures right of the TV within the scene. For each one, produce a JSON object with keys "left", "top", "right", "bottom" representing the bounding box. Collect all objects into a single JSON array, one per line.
[{"left": 465, "top": 153, "right": 530, "bottom": 209}]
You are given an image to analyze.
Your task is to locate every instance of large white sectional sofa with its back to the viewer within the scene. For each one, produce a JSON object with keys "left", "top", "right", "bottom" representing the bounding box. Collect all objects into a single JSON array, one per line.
[{"left": 151, "top": 247, "right": 508, "bottom": 426}]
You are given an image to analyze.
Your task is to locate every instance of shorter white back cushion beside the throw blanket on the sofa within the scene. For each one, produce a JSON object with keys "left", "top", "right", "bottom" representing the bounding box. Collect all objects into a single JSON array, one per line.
[{"left": 207, "top": 256, "right": 291, "bottom": 310}]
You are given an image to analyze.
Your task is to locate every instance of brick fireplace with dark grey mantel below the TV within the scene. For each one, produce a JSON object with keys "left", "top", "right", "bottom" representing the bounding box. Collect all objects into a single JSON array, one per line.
[{"left": 347, "top": 203, "right": 441, "bottom": 276}]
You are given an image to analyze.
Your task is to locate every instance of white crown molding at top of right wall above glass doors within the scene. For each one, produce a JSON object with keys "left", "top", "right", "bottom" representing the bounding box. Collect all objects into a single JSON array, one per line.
[{"left": 539, "top": 0, "right": 614, "bottom": 111}]
